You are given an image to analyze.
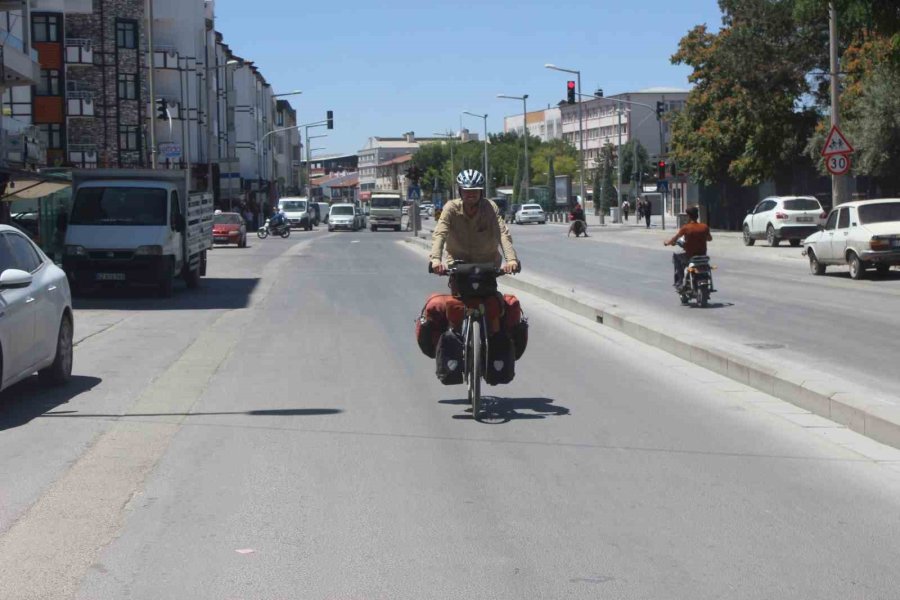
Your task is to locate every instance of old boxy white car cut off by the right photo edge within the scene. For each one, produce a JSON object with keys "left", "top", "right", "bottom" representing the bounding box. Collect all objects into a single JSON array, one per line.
[{"left": 803, "top": 198, "right": 900, "bottom": 279}]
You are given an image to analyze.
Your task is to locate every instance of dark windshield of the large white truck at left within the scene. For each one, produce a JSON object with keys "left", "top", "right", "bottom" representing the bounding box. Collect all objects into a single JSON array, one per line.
[{"left": 70, "top": 187, "right": 168, "bottom": 225}]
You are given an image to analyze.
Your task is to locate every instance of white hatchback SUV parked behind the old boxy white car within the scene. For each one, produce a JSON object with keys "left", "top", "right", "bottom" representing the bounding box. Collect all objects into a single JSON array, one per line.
[{"left": 743, "top": 196, "right": 825, "bottom": 246}]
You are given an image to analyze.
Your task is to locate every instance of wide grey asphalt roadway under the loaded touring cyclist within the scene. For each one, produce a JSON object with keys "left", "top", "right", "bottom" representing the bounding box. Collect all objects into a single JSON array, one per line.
[{"left": 0, "top": 227, "right": 900, "bottom": 600}]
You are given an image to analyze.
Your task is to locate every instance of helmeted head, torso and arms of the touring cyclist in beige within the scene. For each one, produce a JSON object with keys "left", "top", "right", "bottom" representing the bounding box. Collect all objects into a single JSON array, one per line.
[{"left": 431, "top": 169, "right": 519, "bottom": 275}]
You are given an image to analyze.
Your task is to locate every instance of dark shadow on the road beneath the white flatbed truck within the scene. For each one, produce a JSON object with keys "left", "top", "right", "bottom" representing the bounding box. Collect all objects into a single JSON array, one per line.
[{"left": 72, "top": 277, "right": 260, "bottom": 311}]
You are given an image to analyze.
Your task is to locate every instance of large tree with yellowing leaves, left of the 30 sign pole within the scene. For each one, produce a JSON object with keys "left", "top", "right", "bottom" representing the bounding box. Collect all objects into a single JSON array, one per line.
[{"left": 671, "top": 0, "right": 821, "bottom": 185}]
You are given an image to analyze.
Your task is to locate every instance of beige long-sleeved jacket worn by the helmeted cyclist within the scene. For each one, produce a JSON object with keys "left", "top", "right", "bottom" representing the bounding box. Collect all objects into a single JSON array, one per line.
[{"left": 431, "top": 200, "right": 519, "bottom": 267}]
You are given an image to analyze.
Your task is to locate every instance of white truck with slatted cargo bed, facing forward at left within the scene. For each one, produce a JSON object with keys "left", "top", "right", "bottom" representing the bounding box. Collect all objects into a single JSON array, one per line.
[{"left": 63, "top": 169, "right": 213, "bottom": 297}]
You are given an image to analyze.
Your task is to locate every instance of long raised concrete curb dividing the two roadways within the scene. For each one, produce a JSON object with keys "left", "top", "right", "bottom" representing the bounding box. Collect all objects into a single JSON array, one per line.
[{"left": 407, "top": 234, "right": 900, "bottom": 448}]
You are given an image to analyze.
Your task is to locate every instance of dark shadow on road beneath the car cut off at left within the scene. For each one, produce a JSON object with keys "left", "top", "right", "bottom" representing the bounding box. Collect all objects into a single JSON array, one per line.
[{"left": 0, "top": 375, "right": 102, "bottom": 431}]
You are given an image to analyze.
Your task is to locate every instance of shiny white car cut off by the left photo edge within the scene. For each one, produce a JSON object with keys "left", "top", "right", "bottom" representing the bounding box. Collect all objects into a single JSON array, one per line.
[{"left": 0, "top": 225, "right": 74, "bottom": 390}]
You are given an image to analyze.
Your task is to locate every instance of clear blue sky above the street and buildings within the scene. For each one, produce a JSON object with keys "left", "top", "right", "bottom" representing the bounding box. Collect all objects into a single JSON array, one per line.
[{"left": 216, "top": 0, "right": 721, "bottom": 154}]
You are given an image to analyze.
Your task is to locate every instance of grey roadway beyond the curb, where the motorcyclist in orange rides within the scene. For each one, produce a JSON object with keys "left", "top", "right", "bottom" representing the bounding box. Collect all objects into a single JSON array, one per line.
[{"left": 502, "top": 224, "right": 900, "bottom": 399}]
